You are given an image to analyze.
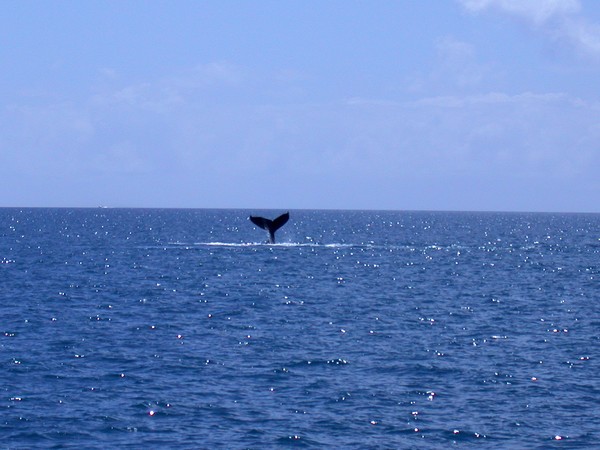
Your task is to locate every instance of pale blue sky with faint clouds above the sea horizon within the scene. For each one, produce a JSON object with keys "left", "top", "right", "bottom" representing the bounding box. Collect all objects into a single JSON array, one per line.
[{"left": 0, "top": 0, "right": 600, "bottom": 212}]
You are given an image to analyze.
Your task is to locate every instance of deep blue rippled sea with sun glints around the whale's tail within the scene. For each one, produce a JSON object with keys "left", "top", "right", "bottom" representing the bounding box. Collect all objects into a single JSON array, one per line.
[{"left": 0, "top": 208, "right": 600, "bottom": 449}]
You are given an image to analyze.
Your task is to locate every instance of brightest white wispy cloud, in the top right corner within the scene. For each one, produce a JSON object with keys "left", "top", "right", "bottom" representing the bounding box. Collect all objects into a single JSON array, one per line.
[{"left": 459, "top": 0, "right": 600, "bottom": 57}]
